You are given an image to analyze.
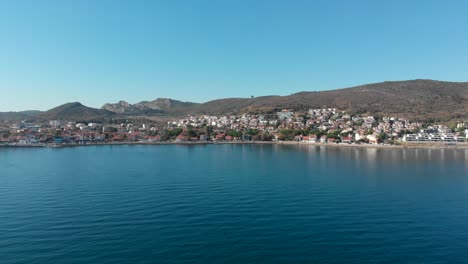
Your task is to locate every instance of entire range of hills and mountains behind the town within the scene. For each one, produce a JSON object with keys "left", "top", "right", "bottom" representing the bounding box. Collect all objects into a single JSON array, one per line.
[{"left": 0, "top": 80, "right": 468, "bottom": 122}]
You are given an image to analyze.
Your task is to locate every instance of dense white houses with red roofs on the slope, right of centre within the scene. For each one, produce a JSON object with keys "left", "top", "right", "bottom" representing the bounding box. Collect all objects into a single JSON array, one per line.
[{"left": 165, "top": 108, "right": 468, "bottom": 144}]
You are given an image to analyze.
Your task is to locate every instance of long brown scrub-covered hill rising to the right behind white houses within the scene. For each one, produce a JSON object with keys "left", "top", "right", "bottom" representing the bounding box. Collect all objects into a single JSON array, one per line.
[{"left": 188, "top": 80, "right": 468, "bottom": 121}]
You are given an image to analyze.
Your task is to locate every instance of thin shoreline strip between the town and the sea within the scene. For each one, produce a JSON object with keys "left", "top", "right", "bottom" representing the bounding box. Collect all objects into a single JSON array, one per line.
[{"left": 0, "top": 141, "right": 468, "bottom": 149}]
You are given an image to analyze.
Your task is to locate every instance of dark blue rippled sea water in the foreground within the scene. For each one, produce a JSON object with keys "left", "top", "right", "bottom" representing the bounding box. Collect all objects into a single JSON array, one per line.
[{"left": 0, "top": 145, "right": 468, "bottom": 264}]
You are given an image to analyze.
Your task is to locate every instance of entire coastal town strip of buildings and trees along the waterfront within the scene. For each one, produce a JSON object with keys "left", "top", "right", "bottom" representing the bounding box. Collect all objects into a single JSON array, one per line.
[{"left": 0, "top": 108, "right": 468, "bottom": 145}]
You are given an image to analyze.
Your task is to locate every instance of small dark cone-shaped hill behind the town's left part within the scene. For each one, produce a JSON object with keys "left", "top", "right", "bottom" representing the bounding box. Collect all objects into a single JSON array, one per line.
[{"left": 36, "top": 102, "right": 115, "bottom": 121}]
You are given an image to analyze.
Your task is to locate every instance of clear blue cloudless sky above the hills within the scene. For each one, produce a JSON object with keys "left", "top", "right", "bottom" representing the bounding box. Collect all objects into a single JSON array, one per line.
[{"left": 0, "top": 0, "right": 468, "bottom": 111}]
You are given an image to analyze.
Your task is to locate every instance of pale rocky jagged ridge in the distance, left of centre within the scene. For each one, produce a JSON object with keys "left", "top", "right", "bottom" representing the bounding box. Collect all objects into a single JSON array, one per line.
[{"left": 102, "top": 98, "right": 197, "bottom": 115}]
